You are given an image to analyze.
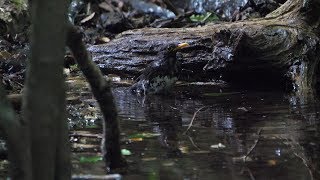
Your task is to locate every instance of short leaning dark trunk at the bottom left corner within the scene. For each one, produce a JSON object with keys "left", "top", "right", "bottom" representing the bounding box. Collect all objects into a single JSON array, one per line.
[{"left": 0, "top": 85, "right": 32, "bottom": 180}]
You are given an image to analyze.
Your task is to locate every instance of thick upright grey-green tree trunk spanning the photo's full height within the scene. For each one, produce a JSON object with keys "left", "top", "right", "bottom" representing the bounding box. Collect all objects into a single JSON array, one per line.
[{"left": 22, "top": 0, "right": 71, "bottom": 180}]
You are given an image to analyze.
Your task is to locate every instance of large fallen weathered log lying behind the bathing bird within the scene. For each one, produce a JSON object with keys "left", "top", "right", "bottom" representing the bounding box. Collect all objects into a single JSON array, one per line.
[{"left": 89, "top": 0, "right": 320, "bottom": 92}]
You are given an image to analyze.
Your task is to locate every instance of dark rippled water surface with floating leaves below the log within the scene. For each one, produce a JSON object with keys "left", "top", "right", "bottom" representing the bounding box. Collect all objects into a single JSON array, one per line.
[{"left": 71, "top": 77, "right": 320, "bottom": 180}]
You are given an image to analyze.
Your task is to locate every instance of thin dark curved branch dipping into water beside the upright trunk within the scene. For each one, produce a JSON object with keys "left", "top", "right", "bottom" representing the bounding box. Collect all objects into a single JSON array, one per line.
[{"left": 67, "top": 26, "right": 126, "bottom": 169}]
